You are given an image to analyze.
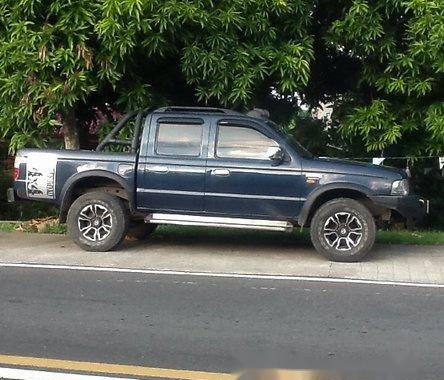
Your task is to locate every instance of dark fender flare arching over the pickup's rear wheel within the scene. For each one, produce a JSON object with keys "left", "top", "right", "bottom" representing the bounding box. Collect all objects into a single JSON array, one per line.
[{"left": 59, "top": 170, "right": 135, "bottom": 222}]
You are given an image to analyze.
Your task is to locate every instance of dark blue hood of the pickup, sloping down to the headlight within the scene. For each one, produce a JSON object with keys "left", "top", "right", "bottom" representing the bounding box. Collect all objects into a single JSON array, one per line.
[{"left": 303, "top": 157, "right": 407, "bottom": 180}]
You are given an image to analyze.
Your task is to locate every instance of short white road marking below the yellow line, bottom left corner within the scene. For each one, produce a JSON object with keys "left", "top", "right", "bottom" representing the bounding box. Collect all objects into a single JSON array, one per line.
[{"left": 0, "top": 367, "right": 135, "bottom": 380}]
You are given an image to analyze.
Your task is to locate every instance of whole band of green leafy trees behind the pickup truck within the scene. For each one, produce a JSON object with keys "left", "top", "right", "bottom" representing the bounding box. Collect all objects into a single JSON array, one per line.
[{"left": 0, "top": 0, "right": 444, "bottom": 155}]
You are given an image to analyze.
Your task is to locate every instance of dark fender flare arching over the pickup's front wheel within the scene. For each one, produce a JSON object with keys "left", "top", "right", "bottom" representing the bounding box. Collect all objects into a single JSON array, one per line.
[{"left": 298, "top": 183, "right": 375, "bottom": 227}]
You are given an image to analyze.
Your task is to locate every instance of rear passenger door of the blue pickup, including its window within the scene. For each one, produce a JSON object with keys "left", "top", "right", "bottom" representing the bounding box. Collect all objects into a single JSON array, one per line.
[{"left": 137, "top": 114, "right": 209, "bottom": 213}]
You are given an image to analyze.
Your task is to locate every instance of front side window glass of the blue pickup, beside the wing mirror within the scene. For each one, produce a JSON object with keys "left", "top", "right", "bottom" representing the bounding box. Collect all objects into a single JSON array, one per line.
[{"left": 216, "top": 125, "right": 279, "bottom": 160}]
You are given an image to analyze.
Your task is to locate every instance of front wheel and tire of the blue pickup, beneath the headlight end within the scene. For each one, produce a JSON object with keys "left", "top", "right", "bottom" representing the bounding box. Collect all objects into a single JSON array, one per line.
[{"left": 310, "top": 198, "right": 376, "bottom": 262}]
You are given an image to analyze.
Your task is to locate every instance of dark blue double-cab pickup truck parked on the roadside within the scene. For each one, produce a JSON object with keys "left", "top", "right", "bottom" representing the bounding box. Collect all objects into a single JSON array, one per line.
[{"left": 8, "top": 107, "right": 426, "bottom": 261}]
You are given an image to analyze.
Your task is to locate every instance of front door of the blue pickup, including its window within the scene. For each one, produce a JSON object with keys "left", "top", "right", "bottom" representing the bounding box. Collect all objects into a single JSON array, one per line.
[{"left": 205, "top": 120, "right": 303, "bottom": 219}]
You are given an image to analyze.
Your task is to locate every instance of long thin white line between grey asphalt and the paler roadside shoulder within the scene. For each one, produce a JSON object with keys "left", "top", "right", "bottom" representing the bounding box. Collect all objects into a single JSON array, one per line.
[{"left": 0, "top": 263, "right": 444, "bottom": 288}]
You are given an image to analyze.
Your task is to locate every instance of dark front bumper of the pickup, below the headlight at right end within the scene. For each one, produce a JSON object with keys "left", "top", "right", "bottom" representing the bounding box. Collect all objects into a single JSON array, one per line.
[{"left": 371, "top": 195, "right": 429, "bottom": 223}]
